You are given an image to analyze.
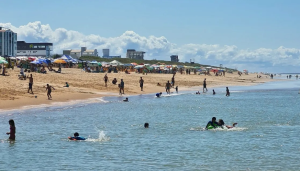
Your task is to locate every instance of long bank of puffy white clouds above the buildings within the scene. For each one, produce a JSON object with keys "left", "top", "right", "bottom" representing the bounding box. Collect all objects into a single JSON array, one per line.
[{"left": 0, "top": 21, "right": 300, "bottom": 72}]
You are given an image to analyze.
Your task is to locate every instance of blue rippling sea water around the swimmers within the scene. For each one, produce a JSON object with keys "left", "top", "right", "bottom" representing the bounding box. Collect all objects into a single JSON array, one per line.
[{"left": 0, "top": 81, "right": 300, "bottom": 170}]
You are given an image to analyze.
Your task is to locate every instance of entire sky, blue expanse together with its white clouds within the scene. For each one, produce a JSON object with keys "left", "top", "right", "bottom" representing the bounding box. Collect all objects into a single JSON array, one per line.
[{"left": 0, "top": 0, "right": 300, "bottom": 73}]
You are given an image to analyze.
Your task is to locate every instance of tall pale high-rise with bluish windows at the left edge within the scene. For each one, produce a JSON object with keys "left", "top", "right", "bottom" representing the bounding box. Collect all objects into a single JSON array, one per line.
[{"left": 0, "top": 27, "right": 17, "bottom": 56}]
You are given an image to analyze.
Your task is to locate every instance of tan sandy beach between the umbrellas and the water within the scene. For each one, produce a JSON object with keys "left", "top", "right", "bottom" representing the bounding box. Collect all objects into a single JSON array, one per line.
[{"left": 0, "top": 68, "right": 276, "bottom": 110}]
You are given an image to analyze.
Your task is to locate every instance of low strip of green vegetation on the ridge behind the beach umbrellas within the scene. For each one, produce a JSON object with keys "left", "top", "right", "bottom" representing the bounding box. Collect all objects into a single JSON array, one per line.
[{"left": 80, "top": 56, "right": 236, "bottom": 71}]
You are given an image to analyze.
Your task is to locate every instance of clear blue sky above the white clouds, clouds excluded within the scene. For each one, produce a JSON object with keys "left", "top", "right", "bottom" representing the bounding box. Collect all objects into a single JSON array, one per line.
[{"left": 0, "top": 0, "right": 300, "bottom": 71}]
